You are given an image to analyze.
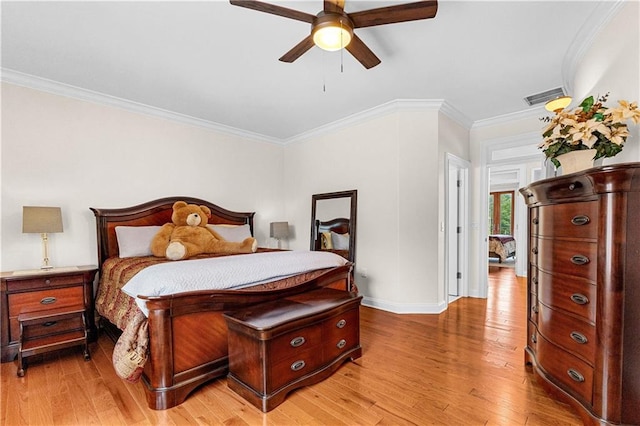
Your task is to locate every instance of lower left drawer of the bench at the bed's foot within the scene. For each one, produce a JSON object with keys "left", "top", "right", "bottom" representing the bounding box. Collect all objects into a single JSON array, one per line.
[{"left": 265, "top": 348, "right": 323, "bottom": 393}]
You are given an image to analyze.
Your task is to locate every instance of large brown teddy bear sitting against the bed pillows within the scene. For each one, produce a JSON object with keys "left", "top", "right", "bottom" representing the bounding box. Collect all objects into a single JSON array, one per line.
[{"left": 151, "top": 201, "right": 258, "bottom": 260}]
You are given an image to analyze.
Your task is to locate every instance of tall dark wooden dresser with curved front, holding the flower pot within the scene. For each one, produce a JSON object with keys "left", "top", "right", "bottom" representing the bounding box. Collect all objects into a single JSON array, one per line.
[{"left": 520, "top": 163, "right": 640, "bottom": 425}]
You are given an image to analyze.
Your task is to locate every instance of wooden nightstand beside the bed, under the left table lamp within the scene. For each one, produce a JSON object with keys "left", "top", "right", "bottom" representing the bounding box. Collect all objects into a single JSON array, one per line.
[{"left": 0, "top": 265, "right": 98, "bottom": 373}]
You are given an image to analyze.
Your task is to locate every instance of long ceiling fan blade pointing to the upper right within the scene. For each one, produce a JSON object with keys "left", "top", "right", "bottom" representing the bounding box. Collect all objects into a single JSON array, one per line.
[{"left": 348, "top": 0, "right": 438, "bottom": 28}]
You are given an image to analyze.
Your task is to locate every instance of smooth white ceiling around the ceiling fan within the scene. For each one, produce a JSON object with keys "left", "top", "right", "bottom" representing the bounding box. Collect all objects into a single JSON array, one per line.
[{"left": 1, "top": 0, "right": 603, "bottom": 141}]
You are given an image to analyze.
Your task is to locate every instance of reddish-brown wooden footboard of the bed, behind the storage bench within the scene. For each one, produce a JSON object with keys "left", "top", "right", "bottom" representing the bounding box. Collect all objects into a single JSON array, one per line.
[{"left": 142, "top": 264, "right": 355, "bottom": 410}]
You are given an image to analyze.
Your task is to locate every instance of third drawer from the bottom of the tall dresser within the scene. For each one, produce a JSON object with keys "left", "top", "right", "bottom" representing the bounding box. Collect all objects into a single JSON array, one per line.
[{"left": 538, "top": 271, "right": 597, "bottom": 323}]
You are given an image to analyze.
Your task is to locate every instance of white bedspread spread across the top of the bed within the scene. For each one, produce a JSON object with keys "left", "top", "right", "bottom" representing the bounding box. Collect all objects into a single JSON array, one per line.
[{"left": 122, "top": 251, "right": 347, "bottom": 315}]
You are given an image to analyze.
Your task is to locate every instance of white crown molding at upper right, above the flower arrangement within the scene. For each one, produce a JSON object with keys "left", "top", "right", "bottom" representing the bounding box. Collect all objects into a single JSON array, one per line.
[{"left": 561, "top": 0, "right": 631, "bottom": 94}]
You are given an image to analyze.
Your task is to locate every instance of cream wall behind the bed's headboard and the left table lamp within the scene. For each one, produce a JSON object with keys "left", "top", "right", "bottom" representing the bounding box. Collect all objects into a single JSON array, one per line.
[{"left": 0, "top": 83, "right": 284, "bottom": 271}]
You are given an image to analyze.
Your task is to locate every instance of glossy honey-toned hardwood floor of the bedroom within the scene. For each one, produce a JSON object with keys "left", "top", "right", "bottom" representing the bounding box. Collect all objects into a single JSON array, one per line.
[{"left": 0, "top": 268, "right": 582, "bottom": 425}]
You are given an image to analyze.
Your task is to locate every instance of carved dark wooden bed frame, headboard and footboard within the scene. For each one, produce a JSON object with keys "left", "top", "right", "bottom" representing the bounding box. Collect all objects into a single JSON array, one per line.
[{"left": 91, "top": 197, "right": 356, "bottom": 409}]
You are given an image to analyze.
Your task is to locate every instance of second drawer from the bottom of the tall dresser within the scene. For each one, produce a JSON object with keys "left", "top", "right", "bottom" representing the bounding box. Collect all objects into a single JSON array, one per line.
[{"left": 538, "top": 303, "right": 596, "bottom": 366}]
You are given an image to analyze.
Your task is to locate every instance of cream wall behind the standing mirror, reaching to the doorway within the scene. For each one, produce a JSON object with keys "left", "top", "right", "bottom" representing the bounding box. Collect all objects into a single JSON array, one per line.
[{"left": 284, "top": 107, "right": 468, "bottom": 312}]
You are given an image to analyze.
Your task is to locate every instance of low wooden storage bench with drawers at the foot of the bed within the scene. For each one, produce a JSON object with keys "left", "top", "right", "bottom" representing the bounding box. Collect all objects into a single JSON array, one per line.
[{"left": 225, "top": 288, "right": 362, "bottom": 412}]
